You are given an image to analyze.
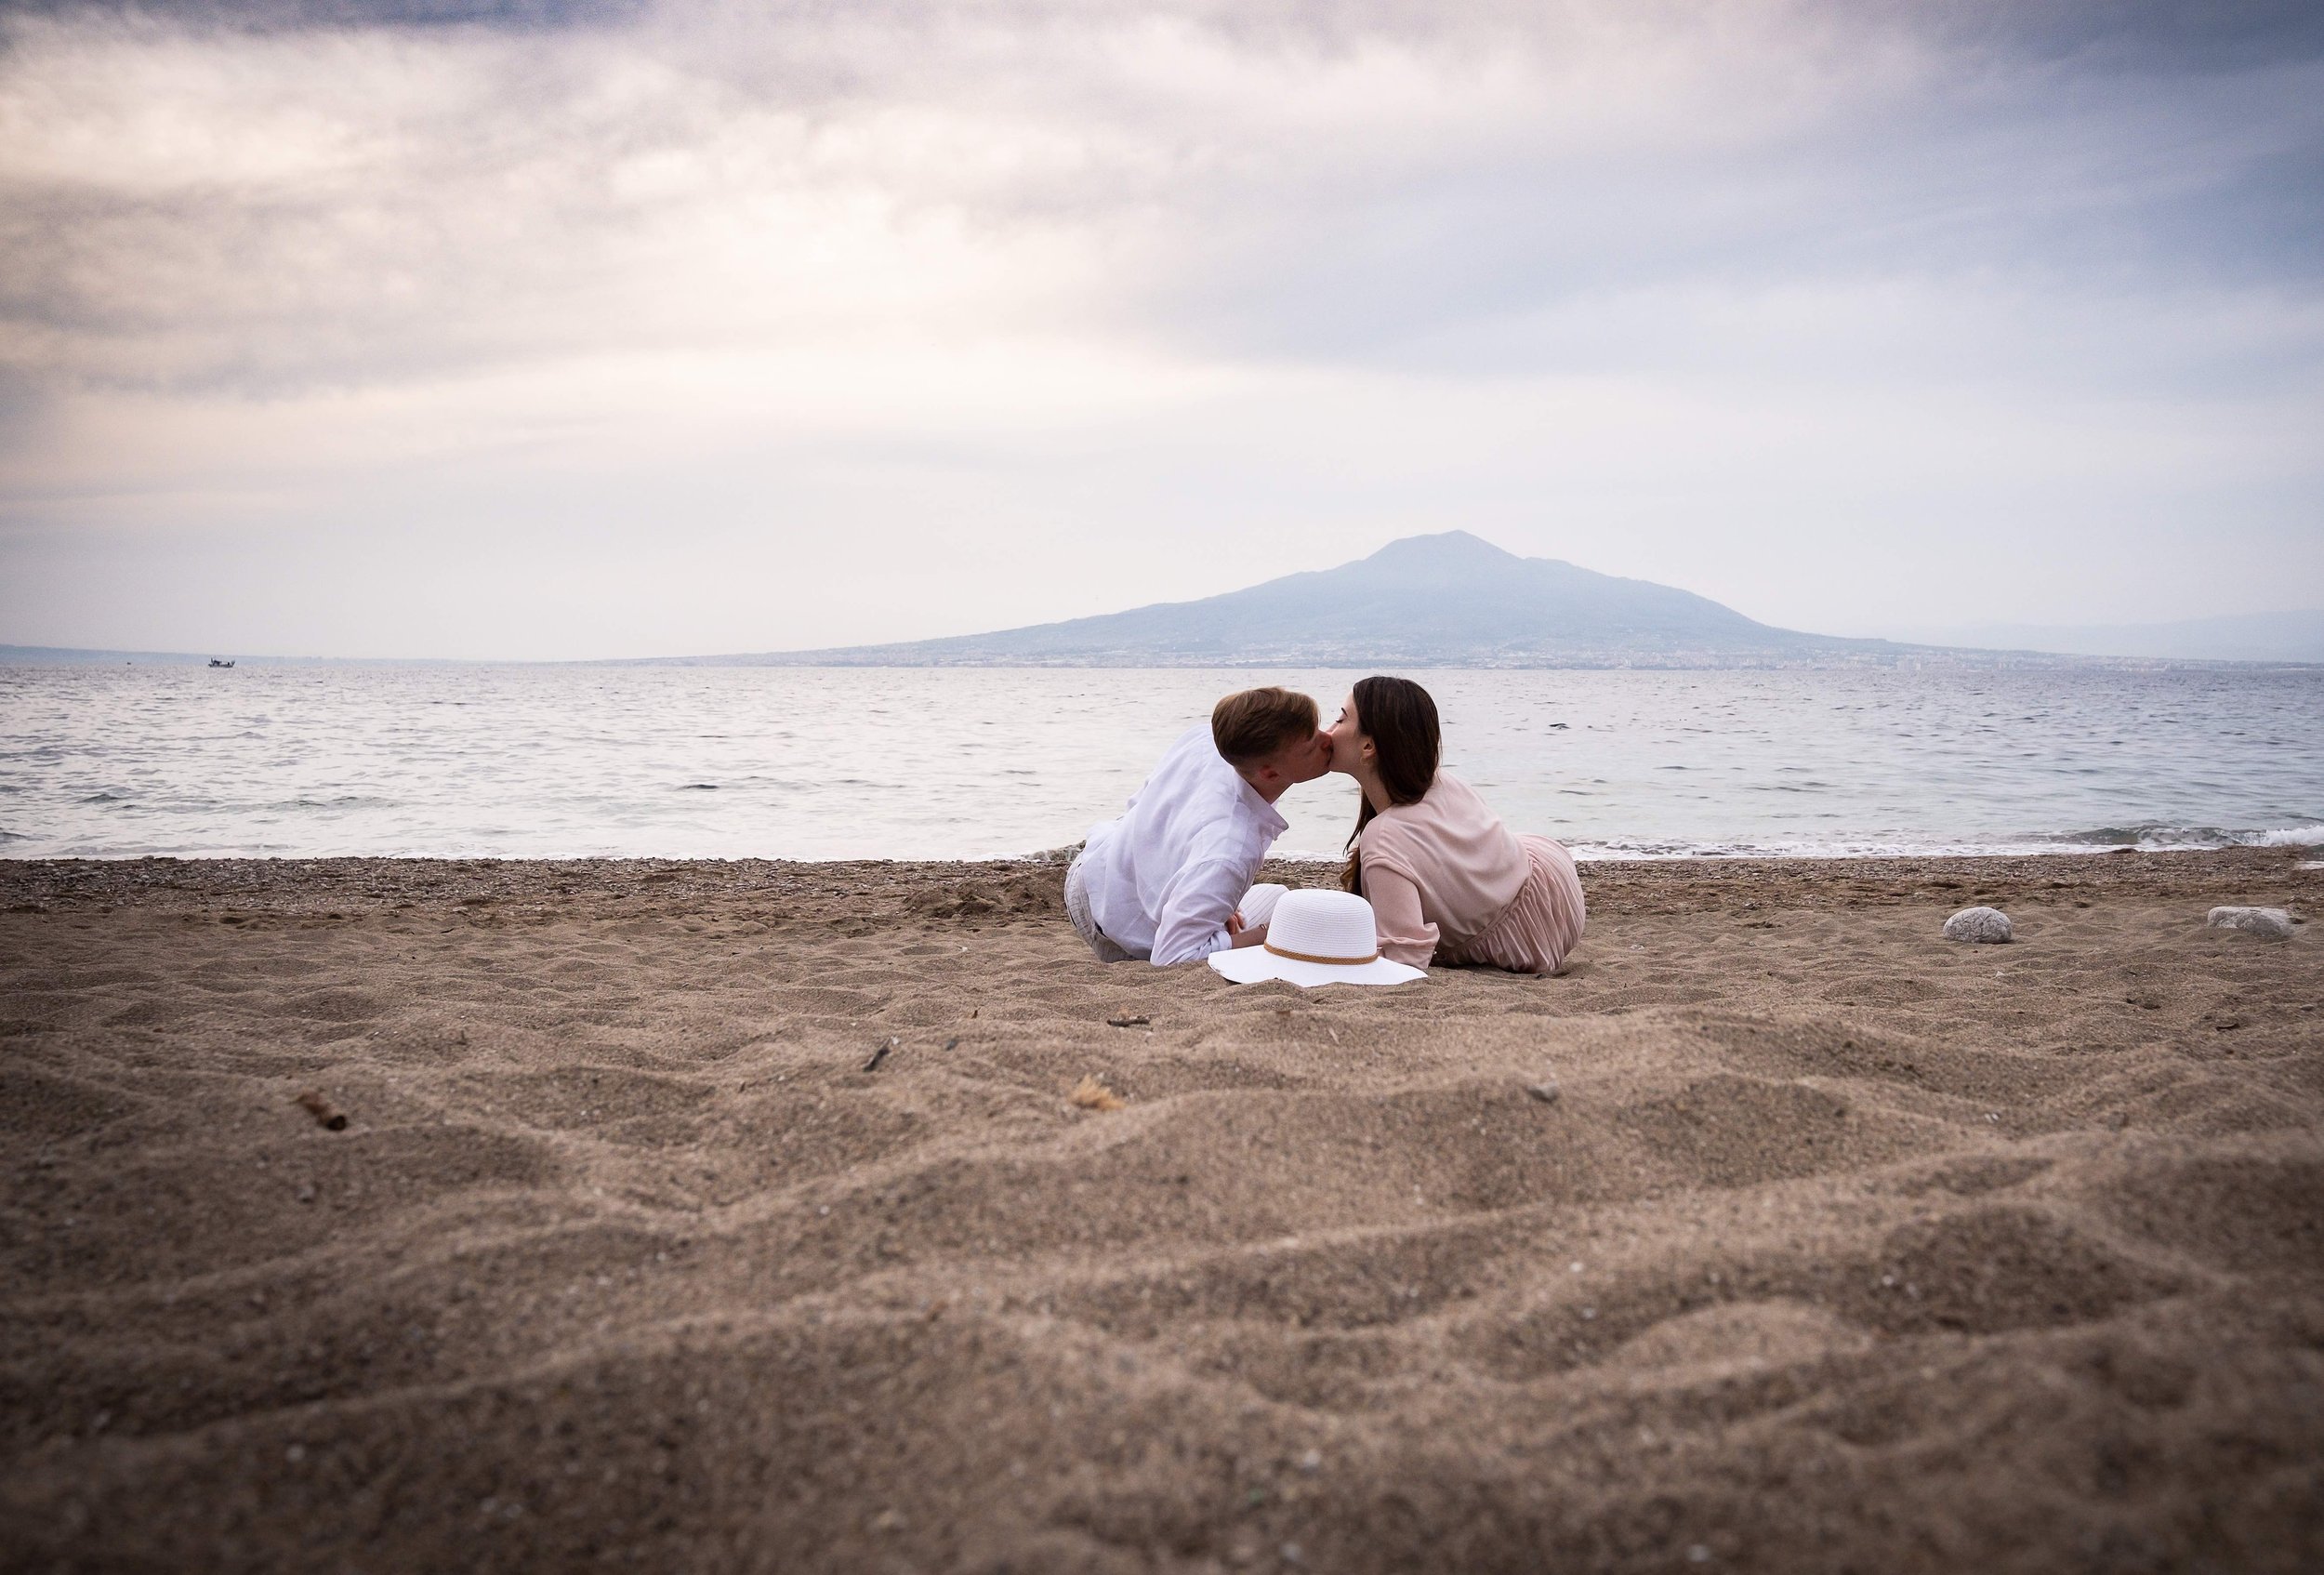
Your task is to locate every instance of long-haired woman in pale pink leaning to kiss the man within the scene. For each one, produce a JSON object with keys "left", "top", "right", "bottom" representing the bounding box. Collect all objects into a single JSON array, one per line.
[{"left": 1332, "top": 679, "right": 1585, "bottom": 973}]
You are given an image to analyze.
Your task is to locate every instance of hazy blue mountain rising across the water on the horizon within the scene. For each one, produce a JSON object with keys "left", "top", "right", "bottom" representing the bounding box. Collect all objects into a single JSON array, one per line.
[{"left": 709, "top": 530, "right": 1901, "bottom": 667}]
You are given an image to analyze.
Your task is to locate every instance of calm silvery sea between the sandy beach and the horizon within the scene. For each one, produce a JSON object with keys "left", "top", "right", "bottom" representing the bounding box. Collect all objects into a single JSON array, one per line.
[{"left": 0, "top": 665, "right": 2324, "bottom": 859}]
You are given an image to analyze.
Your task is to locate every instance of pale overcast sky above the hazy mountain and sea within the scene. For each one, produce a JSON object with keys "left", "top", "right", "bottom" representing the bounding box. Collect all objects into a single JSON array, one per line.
[{"left": 0, "top": 0, "right": 2324, "bottom": 657}]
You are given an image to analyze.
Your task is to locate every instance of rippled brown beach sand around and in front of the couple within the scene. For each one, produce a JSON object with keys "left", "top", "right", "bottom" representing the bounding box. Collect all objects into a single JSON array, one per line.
[{"left": 0, "top": 850, "right": 2324, "bottom": 1573}]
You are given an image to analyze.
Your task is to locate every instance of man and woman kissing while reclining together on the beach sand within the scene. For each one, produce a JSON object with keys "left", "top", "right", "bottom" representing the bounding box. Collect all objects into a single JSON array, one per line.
[{"left": 1064, "top": 679, "right": 1588, "bottom": 983}]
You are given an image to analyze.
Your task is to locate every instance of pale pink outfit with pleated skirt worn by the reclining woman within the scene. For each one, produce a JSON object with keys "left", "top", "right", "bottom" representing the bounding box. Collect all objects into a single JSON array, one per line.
[{"left": 1357, "top": 772, "right": 1588, "bottom": 973}]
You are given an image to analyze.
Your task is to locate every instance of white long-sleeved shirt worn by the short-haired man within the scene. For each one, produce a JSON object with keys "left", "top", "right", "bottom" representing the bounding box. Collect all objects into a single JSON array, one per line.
[{"left": 1081, "top": 722, "right": 1287, "bottom": 966}]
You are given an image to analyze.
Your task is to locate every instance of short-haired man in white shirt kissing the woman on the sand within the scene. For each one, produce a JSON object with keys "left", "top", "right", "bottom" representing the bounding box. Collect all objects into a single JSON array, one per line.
[{"left": 1064, "top": 688, "right": 1332, "bottom": 966}]
